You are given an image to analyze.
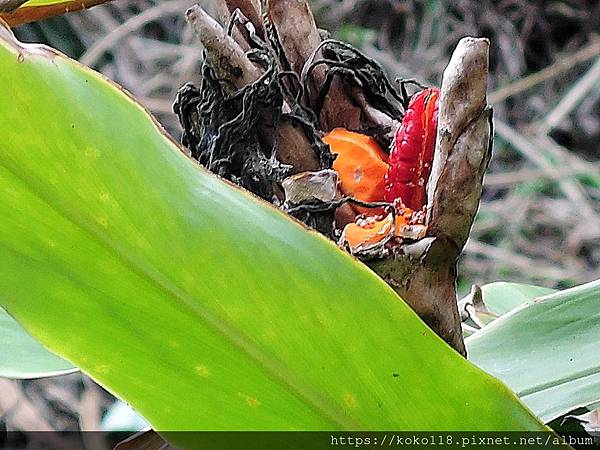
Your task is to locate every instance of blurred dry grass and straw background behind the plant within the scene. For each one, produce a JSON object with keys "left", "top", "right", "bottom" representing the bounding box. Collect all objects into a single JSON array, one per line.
[{"left": 0, "top": 0, "right": 600, "bottom": 436}]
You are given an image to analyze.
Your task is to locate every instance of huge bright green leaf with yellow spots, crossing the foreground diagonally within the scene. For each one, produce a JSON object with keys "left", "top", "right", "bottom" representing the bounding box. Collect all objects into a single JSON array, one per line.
[{"left": 0, "top": 26, "right": 543, "bottom": 438}]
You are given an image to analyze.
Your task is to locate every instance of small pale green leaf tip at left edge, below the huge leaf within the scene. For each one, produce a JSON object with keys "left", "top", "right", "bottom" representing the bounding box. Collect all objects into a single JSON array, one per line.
[{"left": 0, "top": 308, "right": 76, "bottom": 378}]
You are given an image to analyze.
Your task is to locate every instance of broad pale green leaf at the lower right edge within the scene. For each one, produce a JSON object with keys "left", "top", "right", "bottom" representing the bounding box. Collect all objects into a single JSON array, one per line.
[{"left": 466, "top": 281, "right": 600, "bottom": 422}]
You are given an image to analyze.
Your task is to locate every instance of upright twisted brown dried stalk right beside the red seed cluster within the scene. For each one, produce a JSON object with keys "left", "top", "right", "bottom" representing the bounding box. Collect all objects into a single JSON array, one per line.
[{"left": 428, "top": 38, "right": 492, "bottom": 250}]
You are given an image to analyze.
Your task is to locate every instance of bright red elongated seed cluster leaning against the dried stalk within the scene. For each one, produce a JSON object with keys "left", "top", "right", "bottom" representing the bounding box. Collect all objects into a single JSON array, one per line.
[{"left": 384, "top": 88, "right": 440, "bottom": 210}]
